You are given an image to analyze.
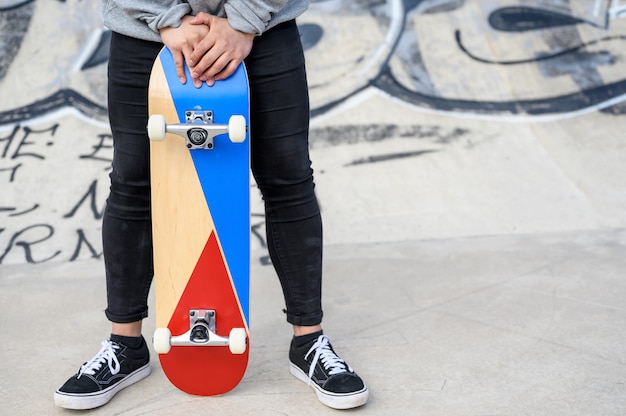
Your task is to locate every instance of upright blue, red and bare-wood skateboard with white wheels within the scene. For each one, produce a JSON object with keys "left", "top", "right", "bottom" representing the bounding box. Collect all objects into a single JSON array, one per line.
[{"left": 147, "top": 48, "right": 250, "bottom": 396}]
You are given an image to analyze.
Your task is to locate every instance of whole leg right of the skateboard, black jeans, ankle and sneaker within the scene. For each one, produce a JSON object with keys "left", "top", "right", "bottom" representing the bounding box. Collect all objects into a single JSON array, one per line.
[{"left": 246, "top": 22, "right": 368, "bottom": 409}]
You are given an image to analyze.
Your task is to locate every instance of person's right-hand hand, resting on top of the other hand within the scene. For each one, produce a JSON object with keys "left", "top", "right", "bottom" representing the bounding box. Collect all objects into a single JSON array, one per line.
[{"left": 185, "top": 13, "right": 255, "bottom": 85}]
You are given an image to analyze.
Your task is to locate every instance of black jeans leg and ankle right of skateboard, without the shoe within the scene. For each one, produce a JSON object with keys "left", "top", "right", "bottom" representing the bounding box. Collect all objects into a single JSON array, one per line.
[{"left": 246, "top": 22, "right": 323, "bottom": 332}]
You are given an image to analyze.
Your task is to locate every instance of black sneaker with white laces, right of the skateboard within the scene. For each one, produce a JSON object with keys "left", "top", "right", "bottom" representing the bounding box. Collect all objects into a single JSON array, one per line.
[{"left": 289, "top": 335, "right": 368, "bottom": 409}]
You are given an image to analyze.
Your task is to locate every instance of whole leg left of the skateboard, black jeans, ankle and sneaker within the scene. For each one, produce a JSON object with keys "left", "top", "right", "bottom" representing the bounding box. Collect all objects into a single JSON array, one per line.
[{"left": 54, "top": 33, "right": 161, "bottom": 409}]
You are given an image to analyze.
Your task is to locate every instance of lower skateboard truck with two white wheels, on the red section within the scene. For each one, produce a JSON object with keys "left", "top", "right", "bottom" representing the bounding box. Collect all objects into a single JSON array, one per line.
[{"left": 153, "top": 309, "right": 248, "bottom": 354}]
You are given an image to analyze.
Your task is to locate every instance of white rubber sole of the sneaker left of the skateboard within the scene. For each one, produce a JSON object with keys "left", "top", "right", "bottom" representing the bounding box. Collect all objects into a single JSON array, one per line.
[{"left": 54, "top": 363, "right": 150, "bottom": 410}]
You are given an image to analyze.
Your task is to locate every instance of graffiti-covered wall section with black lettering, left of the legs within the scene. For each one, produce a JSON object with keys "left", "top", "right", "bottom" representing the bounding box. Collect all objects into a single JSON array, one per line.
[{"left": 0, "top": 0, "right": 112, "bottom": 264}]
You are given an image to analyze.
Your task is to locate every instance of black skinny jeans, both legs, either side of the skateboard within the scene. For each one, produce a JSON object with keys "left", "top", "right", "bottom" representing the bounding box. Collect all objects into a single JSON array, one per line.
[{"left": 102, "top": 21, "right": 322, "bottom": 326}]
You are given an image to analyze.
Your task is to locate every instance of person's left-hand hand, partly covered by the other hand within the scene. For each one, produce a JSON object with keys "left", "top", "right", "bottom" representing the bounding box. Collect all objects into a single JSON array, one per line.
[{"left": 160, "top": 16, "right": 209, "bottom": 87}]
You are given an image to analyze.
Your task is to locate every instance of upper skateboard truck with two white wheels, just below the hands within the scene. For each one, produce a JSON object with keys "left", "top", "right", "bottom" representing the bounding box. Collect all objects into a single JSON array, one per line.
[{"left": 147, "top": 109, "right": 247, "bottom": 150}]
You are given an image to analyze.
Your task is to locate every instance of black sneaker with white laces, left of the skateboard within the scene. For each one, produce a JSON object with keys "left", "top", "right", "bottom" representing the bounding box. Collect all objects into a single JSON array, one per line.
[{"left": 54, "top": 340, "right": 150, "bottom": 409}]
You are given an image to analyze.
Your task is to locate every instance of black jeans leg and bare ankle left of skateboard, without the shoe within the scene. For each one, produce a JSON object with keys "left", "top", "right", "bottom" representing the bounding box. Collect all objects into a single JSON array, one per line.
[{"left": 102, "top": 34, "right": 161, "bottom": 330}]
